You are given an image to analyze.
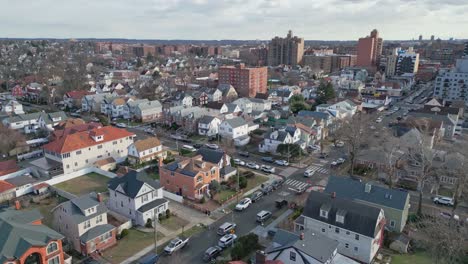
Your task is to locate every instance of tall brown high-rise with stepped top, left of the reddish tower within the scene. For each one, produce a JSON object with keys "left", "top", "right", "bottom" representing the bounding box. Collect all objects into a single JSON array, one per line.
[{"left": 268, "top": 30, "right": 304, "bottom": 66}]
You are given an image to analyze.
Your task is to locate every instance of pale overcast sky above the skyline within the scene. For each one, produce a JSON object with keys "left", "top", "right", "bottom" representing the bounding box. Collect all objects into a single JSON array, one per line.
[{"left": 0, "top": 0, "right": 468, "bottom": 40}]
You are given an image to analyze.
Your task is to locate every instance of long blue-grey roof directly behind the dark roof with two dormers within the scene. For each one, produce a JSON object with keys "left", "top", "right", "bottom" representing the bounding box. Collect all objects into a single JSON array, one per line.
[{"left": 325, "top": 176, "right": 409, "bottom": 210}]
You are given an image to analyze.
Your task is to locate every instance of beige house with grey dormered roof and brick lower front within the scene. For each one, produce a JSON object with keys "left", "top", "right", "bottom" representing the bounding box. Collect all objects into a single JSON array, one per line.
[{"left": 52, "top": 193, "right": 117, "bottom": 256}]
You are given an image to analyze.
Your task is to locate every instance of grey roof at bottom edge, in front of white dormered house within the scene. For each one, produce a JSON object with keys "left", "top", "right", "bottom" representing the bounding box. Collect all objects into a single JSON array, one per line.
[{"left": 266, "top": 229, "right": 338, "bottom": 263}]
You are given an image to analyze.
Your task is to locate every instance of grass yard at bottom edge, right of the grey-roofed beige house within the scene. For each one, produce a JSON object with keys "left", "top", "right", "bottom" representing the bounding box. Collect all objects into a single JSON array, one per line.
[{"left": 104, "top": 229, "right": 164, "bottom": 264}]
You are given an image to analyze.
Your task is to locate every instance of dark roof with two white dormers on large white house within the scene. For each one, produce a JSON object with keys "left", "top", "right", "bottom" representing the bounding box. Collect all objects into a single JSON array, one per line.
[{"left": 303, "top": 191, "right": 381, "bottom": 237}]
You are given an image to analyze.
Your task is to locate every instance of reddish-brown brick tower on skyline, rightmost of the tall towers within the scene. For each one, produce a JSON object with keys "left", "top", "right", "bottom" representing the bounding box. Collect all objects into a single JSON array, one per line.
[{"left": 356, "top": 29, "right": 383, "bottom": 67}]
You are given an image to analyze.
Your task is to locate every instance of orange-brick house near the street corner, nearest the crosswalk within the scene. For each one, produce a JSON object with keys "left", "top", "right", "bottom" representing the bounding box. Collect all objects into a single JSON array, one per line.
[{"left": 159, "top": 155, "right": 220, "bottom": 200}]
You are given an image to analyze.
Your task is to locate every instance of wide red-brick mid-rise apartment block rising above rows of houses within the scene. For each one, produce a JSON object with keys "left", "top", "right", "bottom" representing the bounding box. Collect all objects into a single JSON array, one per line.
[{"left": 218, "top": 63, "right": 268, "bottom": 97}]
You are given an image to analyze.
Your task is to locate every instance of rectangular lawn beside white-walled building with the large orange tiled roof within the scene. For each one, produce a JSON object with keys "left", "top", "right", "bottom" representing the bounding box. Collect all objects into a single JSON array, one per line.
[{"left": 55, "top": 172, "right": 110, "bottom": 195}]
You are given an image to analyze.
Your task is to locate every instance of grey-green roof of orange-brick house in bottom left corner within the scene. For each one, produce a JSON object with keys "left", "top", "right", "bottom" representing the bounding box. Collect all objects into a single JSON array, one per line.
[{"left": 0, "top": 209, "right": 63, "bottom": 263}]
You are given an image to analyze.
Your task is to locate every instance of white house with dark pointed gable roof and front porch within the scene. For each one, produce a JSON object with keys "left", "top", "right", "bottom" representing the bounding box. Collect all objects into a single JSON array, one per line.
[{"left": 108, "top": 171, "right": 169, "bottom": 226}]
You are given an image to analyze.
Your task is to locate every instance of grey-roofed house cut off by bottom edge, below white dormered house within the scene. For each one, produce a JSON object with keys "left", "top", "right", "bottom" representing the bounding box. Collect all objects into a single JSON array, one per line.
[{"left": 266, "top": 229, "right": 359, "bottom": 264}]
